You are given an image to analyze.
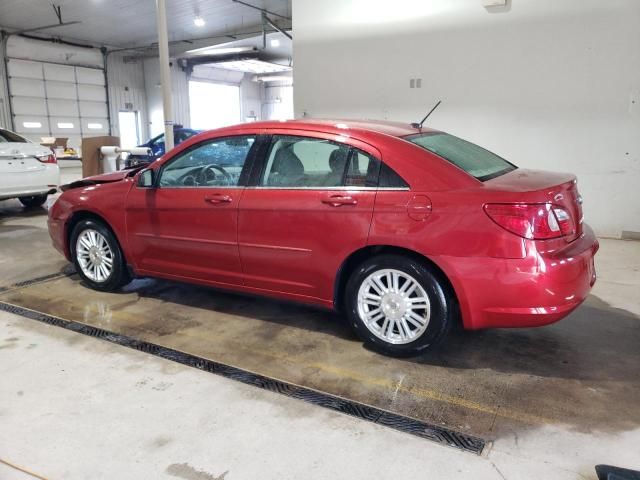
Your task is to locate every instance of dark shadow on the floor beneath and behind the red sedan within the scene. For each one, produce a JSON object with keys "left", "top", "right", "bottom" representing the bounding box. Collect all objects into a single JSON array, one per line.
[{"left": 105, "top": 272, "right": 640, "bottom": 381}]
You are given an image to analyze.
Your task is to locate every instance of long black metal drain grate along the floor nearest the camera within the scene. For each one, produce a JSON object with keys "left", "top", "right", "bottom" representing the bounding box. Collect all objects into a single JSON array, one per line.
[{"left": 0, "top": 300, "right": 485, "bottom": 455}]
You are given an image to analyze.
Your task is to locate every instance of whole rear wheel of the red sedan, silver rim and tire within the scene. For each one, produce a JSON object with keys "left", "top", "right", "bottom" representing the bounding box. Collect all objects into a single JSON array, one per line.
[{"left": 345, "top": 255, "right": 455, "bottom": 357}]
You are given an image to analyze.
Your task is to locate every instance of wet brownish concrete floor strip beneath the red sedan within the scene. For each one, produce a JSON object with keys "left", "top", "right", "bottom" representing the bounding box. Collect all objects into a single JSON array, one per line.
[{"left": 0, "top": 268, "right": 640, "bottom": 438}]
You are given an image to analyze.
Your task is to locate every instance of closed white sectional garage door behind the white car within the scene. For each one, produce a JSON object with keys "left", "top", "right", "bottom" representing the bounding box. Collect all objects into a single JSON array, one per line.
[{"left": 7, "top": 36, "right": 109, "bottom": 147}]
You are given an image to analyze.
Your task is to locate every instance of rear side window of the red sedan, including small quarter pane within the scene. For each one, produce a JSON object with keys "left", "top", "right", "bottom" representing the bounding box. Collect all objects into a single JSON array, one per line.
[{"left": 260, "top": 135, "right": 379, "bottom": 188}]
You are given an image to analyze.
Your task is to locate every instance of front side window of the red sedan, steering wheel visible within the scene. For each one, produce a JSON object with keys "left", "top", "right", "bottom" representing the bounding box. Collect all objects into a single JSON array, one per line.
[{"left": 160, "top": 135, "right": 256, "bottom": 187}]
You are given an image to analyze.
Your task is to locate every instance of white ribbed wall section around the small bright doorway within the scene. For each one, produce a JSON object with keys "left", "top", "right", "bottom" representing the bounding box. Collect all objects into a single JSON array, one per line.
[{"left": 107, "top": 53, "right": 149, "bottom": 142}]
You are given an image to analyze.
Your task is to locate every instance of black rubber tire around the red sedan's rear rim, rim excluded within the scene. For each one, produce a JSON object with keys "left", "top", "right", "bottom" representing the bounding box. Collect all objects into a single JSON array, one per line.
[{"left": 344, "top": 255, "right": 456, "bottom": 357}]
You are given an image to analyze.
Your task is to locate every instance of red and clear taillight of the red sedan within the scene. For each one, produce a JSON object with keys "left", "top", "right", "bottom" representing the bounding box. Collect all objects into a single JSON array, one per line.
[{"left": 484, "top": 203, "right": 575, "bottom": 240}]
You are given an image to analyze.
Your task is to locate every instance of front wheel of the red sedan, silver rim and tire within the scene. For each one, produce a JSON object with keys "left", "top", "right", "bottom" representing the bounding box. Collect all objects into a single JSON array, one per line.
[{"left": 69, "top": 219, "right": 130, "bottom": 291}]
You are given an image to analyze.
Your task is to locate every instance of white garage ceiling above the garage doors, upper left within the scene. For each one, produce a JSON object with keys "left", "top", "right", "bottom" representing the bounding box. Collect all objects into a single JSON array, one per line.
[{"left": 0, "top": 0, "right": 291, "bottom": 49}]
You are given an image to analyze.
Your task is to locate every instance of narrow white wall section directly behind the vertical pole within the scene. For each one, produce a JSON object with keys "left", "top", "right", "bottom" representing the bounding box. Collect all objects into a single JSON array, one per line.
[{"left": 143, "top": 58, "right": 190, "bottom": 137}]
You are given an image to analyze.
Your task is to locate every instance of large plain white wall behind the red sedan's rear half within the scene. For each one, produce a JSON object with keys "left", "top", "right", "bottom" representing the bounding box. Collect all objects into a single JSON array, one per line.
[{"left": 293, "top": 0, "right": 640, "bottom": 236}]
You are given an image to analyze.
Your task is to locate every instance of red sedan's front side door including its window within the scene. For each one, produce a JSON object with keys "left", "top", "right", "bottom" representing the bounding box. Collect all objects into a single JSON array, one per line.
[{"left": 126, "top": 135, "right": 256, "bottom": 285}]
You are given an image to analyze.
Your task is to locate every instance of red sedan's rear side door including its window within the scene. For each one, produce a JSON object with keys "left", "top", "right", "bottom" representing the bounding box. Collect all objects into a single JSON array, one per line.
[{"left": 238, "top": 130, "right": 380, "bottom": 301}]
